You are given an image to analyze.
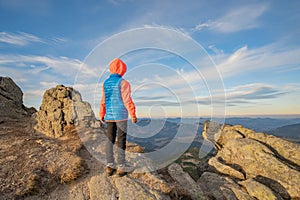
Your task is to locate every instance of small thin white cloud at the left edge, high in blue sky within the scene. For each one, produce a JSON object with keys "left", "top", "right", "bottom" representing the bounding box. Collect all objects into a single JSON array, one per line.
[{"left": 0, "top": 32, "right": 44, "bottom": 46}]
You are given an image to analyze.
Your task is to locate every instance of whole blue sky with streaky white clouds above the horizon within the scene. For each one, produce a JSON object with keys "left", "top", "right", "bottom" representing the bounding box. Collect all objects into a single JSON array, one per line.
[{"left": 0, "top": 0, "right": 300, "bottom": 117}]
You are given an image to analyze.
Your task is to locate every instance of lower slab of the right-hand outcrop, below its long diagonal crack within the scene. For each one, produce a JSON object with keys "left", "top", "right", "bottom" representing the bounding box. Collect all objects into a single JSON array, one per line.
[{"left": 218, "top": 139, "right": 300, "bottom": 198}]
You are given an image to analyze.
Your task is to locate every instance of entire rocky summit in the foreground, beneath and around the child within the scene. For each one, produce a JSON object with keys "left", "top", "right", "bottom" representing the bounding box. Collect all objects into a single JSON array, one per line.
[{"left": 0, "top": 77, "right": 300, "bottom": 200}]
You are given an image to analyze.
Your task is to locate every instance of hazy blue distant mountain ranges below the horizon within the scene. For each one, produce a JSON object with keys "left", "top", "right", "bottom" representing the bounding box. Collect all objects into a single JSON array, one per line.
[{"left": 128, "top": 117, "right": 300, "bottom": 152}]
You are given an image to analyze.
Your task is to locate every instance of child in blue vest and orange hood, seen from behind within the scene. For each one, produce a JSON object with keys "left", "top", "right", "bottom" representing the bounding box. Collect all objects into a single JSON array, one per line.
[{"left": 99, "top": 58, "right": 137, "bottom": 176}]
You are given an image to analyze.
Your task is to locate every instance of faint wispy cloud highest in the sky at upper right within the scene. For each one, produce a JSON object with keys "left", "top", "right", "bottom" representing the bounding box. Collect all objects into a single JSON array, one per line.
[{"left": 193, "top": 4, "right": 268, "bottom": 33}]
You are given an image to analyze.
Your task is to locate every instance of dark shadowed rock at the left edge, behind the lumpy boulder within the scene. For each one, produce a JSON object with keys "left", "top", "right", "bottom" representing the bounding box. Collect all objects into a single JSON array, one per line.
[{"left": 0, "top": 76, "right": 36, "bottom": 117}]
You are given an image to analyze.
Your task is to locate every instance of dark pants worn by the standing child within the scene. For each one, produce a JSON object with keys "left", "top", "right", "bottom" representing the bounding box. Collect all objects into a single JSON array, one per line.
[{"left": 106, "top": 121, "right": 127, "bottom": 164}]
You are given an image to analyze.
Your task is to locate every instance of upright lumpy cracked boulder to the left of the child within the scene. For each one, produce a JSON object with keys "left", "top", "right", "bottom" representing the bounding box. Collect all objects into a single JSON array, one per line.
[{"left": 35, "top": 85, "right": 97, "bottom": 138}]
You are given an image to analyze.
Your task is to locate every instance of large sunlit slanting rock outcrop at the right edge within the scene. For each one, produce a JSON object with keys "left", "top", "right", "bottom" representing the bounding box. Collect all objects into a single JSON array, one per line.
[{"left": 200, "top": 122, "right": 300, "bottom": 199}]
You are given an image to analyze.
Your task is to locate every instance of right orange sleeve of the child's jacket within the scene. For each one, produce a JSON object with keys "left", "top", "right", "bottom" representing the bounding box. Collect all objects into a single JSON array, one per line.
[{"left": 121, "top": 80, "right": 136, "bottom": 118}]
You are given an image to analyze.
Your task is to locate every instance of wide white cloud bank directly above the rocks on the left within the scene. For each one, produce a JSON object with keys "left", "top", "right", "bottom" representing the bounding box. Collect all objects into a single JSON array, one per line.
[{"left": 0, "top": 55, "right": 98, "bottom": 108}]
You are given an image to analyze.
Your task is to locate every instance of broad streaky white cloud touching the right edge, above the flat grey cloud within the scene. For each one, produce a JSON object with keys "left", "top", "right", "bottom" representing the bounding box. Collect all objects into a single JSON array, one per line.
[{"left": 212, "top": 43, "right": 300, "bottom": 78}]
